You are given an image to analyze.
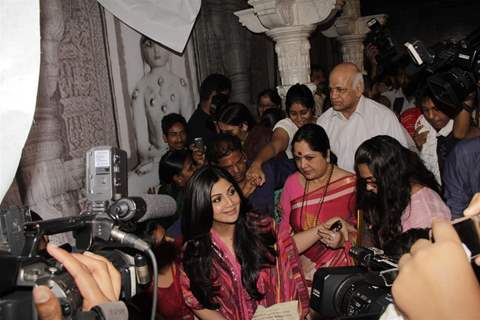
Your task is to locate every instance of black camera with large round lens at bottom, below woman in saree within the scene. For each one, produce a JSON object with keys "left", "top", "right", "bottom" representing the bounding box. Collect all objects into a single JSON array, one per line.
[{"left": 310, "top": 247, "right": 398, "bottom": 319}]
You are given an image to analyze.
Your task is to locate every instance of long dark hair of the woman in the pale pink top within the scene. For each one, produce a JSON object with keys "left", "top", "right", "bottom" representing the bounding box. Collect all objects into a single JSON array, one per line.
[{"left": 355, "top": 136, "right": 440, "bottom": 247}]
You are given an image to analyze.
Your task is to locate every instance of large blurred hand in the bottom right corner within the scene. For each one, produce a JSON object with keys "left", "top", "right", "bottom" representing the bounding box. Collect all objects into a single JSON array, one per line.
[{"left": 392, "top": 220, "right": 480, "bottom": 320}]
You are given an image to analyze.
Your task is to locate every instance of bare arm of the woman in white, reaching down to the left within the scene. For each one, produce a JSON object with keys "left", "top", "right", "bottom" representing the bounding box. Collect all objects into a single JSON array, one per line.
[{"left": 247, "top": 128, "right": 289, "bottom": 185}]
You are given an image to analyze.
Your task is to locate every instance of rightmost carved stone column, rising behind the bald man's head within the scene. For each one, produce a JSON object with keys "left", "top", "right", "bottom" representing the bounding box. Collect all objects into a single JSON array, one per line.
[{"left": 323, "top": 0, "right": 386, "bottom": 70}]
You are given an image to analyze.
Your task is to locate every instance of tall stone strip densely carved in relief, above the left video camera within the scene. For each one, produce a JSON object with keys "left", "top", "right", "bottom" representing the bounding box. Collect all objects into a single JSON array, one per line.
[{"left": 59, "top": 1, "right": 116, "bottom": 159}]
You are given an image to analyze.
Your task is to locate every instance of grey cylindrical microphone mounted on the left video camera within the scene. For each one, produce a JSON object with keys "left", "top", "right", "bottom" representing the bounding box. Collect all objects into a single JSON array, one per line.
[{"left": 109, "top": 194, "right": 177, "bottom": 222}]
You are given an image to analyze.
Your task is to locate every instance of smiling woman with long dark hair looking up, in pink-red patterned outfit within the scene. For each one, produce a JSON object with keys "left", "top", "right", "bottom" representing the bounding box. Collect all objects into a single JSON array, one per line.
[{"left": 181, "top": 166, "right": 308, "bottom": 320}]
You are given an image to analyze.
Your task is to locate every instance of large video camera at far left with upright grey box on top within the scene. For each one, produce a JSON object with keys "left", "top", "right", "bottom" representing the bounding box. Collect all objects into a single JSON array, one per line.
[{"left": 0, "top": 147, "right": 150, "bottom": 319}]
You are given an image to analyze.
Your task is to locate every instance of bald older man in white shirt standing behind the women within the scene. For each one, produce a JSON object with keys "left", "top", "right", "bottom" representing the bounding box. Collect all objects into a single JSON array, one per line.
[{"left": 317, "top": 63, "right": 416, "bottom": 172}]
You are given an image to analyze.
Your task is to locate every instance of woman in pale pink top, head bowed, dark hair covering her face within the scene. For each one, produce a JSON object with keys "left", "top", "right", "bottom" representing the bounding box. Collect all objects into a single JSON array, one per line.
[{"left": 355, "top": 136, "right": 451, "bottom": 247}]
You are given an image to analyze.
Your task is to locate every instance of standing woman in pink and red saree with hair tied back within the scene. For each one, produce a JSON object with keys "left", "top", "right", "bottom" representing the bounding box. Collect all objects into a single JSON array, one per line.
[{"left": 280, "top": 124, "right": 356, "bottom": 286}]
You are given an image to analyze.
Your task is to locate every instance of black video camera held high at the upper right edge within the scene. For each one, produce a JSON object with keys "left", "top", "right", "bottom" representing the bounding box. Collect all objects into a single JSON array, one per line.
[{"left": 405, "top": 28, "right": 480, "bottom": 118}]
